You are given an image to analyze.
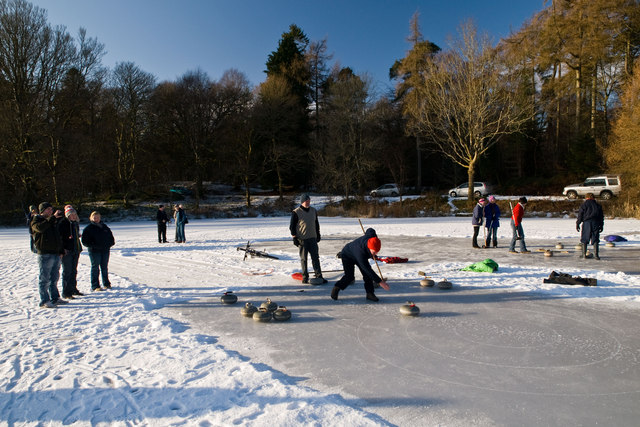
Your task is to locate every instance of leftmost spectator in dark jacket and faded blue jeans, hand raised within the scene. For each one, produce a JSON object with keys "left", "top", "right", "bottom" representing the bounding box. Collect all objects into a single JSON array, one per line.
[{"left": 31, "top": 202, "right": 67, "bottom": 308}]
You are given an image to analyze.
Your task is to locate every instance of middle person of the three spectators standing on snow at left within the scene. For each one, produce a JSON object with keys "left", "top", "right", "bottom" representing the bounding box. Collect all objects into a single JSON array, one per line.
[{"left": 58, "top": 205, "right": 83, "bottom": 299}]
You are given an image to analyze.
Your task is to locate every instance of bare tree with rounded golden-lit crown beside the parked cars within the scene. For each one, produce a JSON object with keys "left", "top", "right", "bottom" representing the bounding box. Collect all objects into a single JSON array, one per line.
[{"left": 406, "top": 23, "right": 532, "bottom": 200}]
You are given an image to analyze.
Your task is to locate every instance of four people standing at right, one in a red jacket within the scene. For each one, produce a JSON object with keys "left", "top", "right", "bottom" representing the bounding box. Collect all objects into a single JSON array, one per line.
[{"left": 471, "top": 193, "right": 604, "bottom": 260}]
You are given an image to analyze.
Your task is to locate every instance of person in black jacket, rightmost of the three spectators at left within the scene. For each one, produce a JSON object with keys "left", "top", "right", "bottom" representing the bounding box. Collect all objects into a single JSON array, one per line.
[{"left": 82, "top": 212, "right": 116, "bottom": 291}]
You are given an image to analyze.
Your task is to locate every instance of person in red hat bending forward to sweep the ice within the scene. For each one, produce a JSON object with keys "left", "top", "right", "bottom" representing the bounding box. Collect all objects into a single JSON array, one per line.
[{"left": 331, "top": 228, "right": 389, "bottom": 301}]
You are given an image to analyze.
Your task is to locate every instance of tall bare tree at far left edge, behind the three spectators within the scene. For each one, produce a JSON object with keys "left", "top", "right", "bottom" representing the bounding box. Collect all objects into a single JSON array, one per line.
[{"left": 0, "top": 0, "right": 73, "bottom": 207}]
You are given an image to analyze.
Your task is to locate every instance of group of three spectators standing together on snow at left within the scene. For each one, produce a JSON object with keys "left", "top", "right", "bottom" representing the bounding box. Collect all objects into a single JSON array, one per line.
[{"left": 28, "top": 202, "right": 115, "bottom": 308}]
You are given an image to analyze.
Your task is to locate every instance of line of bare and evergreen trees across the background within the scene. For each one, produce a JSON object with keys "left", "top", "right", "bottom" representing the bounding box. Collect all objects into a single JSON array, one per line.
[{"left": 0, "top": 0, "right": 640, "bottom": 214}]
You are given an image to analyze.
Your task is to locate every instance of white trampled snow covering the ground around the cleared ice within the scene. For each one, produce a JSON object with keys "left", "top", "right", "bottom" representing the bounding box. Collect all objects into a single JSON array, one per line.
[{"left": 0, "top": 217, "right": 640, "bottom": 426}]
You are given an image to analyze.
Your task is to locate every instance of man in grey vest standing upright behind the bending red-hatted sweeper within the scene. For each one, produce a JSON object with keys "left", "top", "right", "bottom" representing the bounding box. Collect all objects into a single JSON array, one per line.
[{"left": 289, "top": 194, "right": 327, "bottom": 283}]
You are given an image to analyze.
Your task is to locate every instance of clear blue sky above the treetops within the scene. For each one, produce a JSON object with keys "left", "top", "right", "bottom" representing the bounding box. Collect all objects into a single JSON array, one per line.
[{"left": 31, "top": 0, "right": 544, "bottom": 91}]
